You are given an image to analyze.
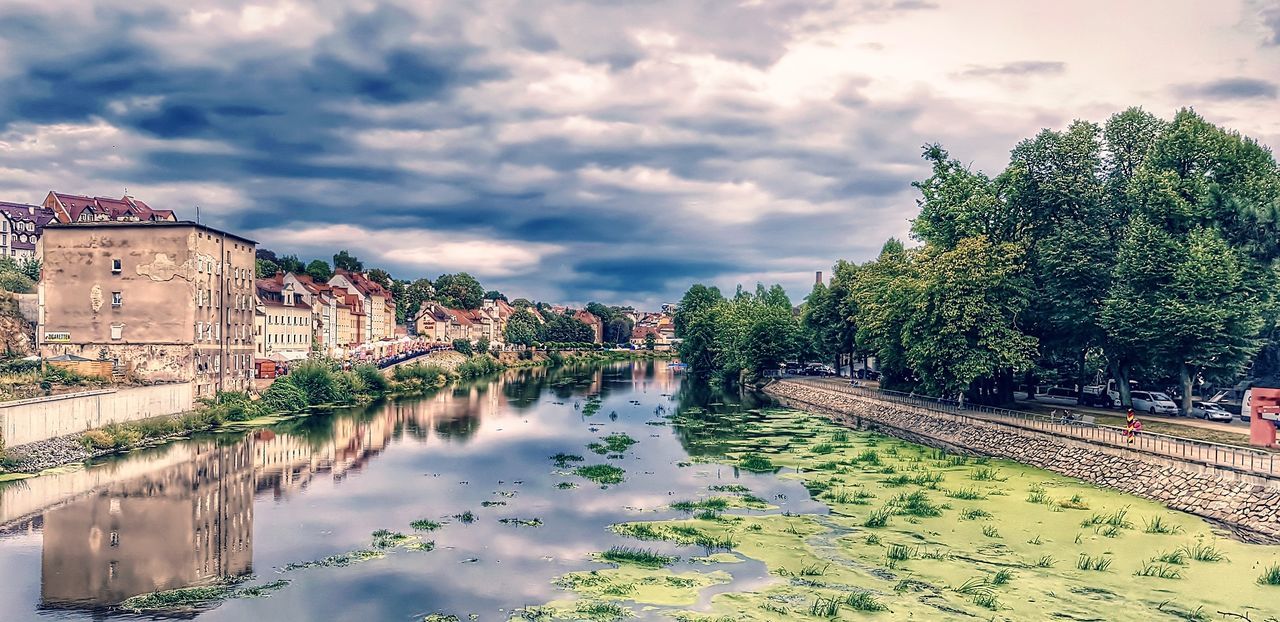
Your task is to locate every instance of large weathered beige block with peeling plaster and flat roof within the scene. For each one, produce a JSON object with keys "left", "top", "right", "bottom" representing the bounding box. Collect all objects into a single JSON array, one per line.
[{"left": 37, "top": 220, "right": 256, "bottom": 397}]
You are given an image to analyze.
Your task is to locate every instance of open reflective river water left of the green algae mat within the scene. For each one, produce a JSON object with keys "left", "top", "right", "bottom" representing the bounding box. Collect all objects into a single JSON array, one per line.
[{"left": 0, "top": 361, "right": 808, "bottom": 621}]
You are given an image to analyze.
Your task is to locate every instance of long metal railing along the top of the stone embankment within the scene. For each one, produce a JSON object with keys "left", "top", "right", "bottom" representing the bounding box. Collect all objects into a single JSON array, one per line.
[{"left": 794, "top": 378, "right": 1280, "bottom": 477}]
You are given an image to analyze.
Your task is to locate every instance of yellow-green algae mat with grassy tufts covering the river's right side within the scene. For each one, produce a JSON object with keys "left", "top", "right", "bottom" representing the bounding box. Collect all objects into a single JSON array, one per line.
[{"left": 527, "top": 407, "right": 1280, "bottom": 621}]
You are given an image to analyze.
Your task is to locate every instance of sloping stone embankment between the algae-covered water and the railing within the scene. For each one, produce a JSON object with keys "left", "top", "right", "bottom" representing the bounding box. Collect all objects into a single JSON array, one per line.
[{"left": 765, "top": 381, "right": 1280, "bottom": 543}]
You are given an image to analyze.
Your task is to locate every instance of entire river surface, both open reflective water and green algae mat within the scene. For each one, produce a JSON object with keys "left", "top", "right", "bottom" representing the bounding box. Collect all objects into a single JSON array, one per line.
[{"left": 0, "top": 362, "right": 1280, "bottom": 622}]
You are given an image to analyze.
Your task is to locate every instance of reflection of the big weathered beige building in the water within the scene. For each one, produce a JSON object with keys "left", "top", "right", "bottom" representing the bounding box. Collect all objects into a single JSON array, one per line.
[{"left": 41, "top": 439, "right": 253, "bottom": 607}]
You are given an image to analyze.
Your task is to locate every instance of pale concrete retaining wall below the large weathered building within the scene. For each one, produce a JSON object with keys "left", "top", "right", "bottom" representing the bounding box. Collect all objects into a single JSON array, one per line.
[{"left": 0, "top": 383, "right": 195, "bottom": 447}]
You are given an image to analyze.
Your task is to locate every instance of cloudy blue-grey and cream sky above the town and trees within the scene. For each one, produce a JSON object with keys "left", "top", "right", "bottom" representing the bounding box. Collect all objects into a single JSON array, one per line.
[{"left": 0, "top": 0, "right": 1280, "bottom": 308}]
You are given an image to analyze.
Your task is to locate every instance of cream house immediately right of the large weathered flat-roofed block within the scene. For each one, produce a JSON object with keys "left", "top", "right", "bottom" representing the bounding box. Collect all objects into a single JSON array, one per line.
[{"left": 253, "top": 279, "right": 316, "bottom": 361}]
